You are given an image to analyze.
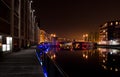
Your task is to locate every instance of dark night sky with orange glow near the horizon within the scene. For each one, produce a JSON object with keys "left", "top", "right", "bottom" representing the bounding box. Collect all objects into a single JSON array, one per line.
[{"left": 33, "top": 0, "right": 120, "bottom": 39}]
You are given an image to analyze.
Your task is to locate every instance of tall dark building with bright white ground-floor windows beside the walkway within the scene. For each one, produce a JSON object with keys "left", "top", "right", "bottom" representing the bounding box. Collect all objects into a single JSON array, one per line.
[{"left": 0, "top": 0, "right": 38, "bottom": 52}]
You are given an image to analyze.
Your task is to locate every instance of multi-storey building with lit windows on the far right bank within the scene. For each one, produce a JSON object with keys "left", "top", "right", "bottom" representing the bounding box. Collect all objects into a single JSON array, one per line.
[{"left": 99, "top": 21, "right": 120, "bottom": 44}]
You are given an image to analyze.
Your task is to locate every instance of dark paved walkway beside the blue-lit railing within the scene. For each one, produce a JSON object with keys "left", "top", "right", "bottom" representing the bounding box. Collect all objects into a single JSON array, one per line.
[{"left": 0, "top": 49, "right": 44, "bottom": 77}]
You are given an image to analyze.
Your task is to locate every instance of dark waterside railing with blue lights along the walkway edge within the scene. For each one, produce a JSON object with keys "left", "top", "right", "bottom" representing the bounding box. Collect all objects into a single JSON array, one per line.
[{"left": 36, "top": 47, "right": 69, "bottom": 77}]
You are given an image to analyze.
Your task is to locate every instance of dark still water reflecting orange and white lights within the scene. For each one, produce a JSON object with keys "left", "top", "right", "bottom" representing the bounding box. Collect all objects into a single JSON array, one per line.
[{"left": 47, "top": 48, "right": 120, "bottom": 77}]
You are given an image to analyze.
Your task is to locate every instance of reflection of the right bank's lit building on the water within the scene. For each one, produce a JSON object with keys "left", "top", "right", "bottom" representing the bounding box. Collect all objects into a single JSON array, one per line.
[{"left": 98, "top": 48, "right": 120, "bottom": 72}]
